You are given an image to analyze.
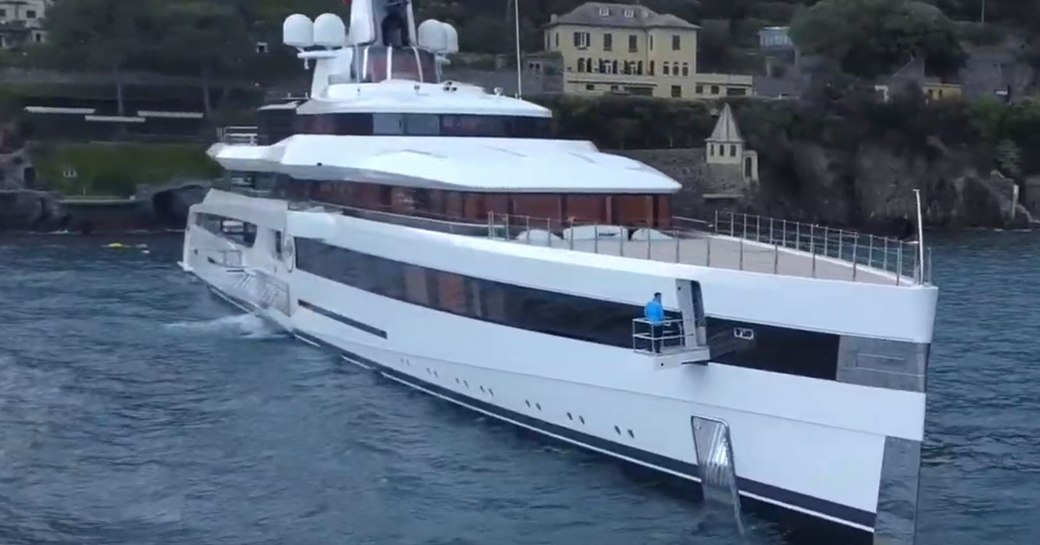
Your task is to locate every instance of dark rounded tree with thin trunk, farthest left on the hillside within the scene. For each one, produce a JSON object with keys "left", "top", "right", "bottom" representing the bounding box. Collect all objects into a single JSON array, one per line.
[{"left": 47, "top": 0, "right": 159, "bottom": 115}]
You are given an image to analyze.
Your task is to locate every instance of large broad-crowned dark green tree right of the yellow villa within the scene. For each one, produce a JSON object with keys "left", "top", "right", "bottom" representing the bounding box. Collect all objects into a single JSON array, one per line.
[{"left": 790, "top": 0, "right": 965, "bottom": 78}]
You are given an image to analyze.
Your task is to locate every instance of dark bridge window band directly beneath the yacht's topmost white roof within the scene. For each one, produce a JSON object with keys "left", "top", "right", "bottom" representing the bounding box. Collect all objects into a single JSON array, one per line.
[{"left": 294, "top": 113, "right": 552, "bottom": 138}]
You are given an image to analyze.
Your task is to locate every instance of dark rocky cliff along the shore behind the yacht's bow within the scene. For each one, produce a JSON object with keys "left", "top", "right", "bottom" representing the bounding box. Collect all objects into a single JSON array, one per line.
[{"left": 624, "top": 140, "right": 1040, "bottom": 230}]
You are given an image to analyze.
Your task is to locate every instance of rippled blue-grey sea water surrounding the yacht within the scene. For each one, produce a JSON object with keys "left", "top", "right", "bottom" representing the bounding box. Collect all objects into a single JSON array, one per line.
[{"left": 0, "top": 233, "right": 1040, "bottom": 545}]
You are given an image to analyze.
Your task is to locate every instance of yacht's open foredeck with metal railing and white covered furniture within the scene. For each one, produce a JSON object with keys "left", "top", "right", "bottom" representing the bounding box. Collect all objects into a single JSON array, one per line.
[{"left": 487, "top": 212, "right": 932, "bottom": 285}]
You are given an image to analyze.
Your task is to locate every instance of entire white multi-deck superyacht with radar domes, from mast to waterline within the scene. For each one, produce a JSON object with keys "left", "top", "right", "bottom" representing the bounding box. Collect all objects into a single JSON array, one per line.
[{"left": 182, "top": 0, "right": 937, "bottom": 544}]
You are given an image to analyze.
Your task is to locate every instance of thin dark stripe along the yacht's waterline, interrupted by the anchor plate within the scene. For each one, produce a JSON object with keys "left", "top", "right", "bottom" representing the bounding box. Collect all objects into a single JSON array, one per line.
[{"left": 293, "top": 331, "right": 877, "bottom": 528}]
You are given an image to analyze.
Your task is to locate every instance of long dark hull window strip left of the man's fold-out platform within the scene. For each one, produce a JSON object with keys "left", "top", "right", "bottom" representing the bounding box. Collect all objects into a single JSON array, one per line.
[{"left": 295, "top": 238, "right": 643, "bottom": 347}]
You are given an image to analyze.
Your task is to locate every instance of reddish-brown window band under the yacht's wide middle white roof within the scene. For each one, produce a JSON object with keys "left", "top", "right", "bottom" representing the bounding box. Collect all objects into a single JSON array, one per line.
[{"left": 274, "top": 177, "right": 672, "bottom": 230}]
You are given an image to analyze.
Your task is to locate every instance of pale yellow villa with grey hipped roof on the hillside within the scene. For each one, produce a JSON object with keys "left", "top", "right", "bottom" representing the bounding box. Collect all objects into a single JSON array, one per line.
[{"left": 545, "top": 2, "right": 752, "bottom": 99}]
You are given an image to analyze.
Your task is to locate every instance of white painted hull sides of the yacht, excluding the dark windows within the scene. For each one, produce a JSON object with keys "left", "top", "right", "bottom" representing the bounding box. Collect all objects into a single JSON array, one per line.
[{"left": 183, "top": 191, "right": 935, "bottom": 535}]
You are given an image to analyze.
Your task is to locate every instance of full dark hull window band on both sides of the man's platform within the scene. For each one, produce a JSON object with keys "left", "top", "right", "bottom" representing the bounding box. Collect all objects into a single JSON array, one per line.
[{"left": 295, "top": 238, "right": 839, "bottom": 380}]
